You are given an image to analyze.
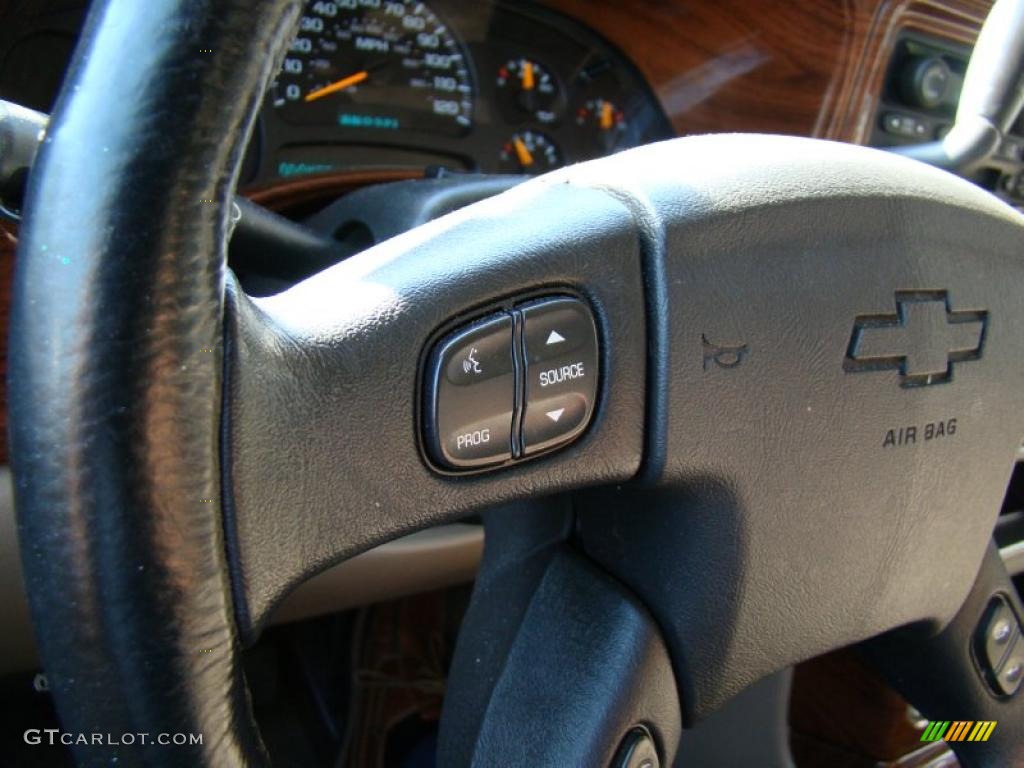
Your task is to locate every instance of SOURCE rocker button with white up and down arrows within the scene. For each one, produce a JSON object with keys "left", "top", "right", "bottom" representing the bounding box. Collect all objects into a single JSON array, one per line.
[{"left": 521, "top": 298, "right": 598, "bottom": 456}]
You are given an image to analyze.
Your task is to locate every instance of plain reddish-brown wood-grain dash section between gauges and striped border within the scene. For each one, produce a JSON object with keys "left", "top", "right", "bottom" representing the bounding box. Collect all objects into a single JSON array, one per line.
[{"left": 548, "top": 0, "right": 853, "bottom": 136}]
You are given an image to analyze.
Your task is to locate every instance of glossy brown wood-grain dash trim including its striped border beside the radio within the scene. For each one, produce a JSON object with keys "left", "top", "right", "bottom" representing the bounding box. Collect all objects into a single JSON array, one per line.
[{"left": 547, "top": 0, "right": 991, "bottom": 143}]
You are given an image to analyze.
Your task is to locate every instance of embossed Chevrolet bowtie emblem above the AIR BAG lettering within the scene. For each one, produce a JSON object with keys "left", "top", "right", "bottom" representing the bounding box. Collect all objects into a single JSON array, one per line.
[{"left": 843, "top": 291, "right": 988, "bottom": 387}]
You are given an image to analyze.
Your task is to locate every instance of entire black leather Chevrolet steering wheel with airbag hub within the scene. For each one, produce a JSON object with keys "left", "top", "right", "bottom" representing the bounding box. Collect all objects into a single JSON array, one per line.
[{"left": 10, "top": 0, "right": 1024, "bottom": 766}]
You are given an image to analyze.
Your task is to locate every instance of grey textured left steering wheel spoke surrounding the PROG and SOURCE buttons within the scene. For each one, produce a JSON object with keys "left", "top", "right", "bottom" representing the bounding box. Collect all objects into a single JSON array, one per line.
[{"left": 224, "top": 182, "right": 646, "bottom": 632}]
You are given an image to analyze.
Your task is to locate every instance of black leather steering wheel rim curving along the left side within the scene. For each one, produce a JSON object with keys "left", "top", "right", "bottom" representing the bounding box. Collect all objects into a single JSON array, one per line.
[{"left": 10, "top": 0, "right": 300, "bottom": 765}]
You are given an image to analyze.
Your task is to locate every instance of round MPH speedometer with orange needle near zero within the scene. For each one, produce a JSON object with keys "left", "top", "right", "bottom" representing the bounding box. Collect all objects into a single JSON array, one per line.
[{"left": 272, "top": 0, "right": 473, "bottom": 135}]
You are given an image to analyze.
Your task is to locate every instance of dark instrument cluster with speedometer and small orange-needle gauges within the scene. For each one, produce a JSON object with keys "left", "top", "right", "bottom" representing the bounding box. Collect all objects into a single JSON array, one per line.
[{"left": 243, "top": 0, "right": 673, "bottom": 184}]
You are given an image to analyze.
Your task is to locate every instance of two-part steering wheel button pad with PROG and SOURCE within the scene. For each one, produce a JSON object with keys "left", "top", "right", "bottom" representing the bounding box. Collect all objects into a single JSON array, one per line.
[{"left": 423, "top": 297, "right": 599, "bottom": 470}]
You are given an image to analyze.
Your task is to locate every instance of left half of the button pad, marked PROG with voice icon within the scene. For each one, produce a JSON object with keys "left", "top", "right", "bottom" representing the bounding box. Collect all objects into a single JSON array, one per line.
[{"left": 426, "top": 314, "right": 515, "bottom": 469}]
